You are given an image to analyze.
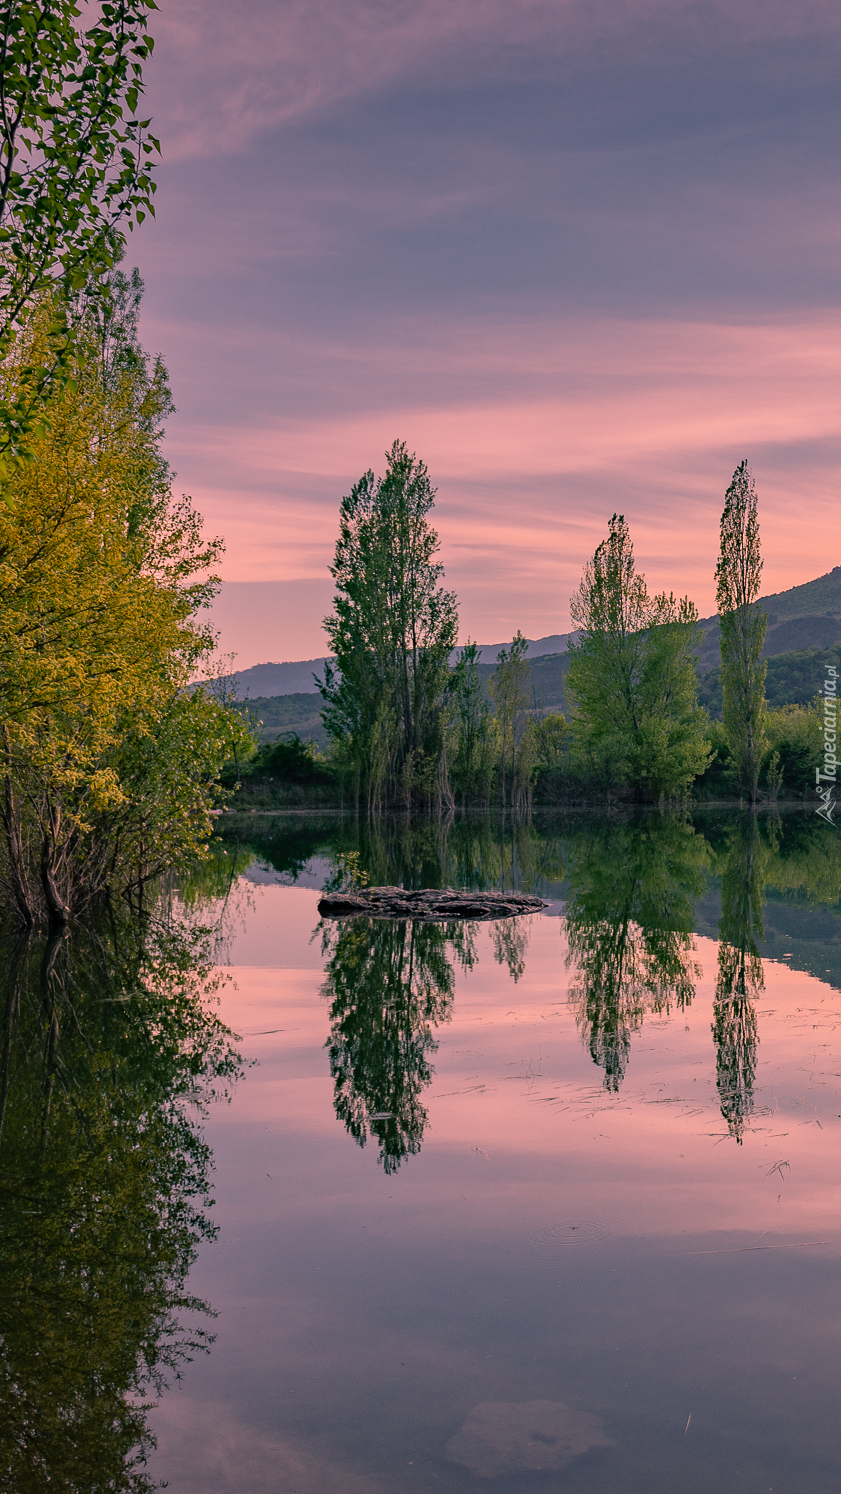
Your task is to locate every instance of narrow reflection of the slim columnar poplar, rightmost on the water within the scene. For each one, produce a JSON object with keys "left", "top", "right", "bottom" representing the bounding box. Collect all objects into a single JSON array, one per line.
[{"left": 713, "top": 814, "right": 768, "bottom": 1143}]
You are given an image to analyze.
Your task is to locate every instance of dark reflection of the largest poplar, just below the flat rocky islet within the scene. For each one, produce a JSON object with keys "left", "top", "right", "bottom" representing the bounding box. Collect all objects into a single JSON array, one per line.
[{"left": 324, "top": 919, "right": 477, "bottom": 1173}]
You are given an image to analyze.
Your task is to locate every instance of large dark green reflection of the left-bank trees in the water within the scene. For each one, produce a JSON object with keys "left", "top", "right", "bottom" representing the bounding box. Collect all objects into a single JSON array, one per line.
[{"left": 0, "top": 916, "right": 239, "bottom": 1494}]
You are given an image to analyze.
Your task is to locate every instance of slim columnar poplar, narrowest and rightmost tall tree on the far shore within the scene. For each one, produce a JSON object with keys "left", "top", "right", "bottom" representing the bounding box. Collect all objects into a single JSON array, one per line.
[{"left": 716, "top": 462, "right": 768, "bottom": 802}]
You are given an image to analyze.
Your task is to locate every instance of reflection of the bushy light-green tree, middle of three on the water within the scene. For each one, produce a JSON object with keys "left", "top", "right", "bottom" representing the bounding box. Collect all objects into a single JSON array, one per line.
[{"left": 566, "top": 814, "right": 708, "bottom": 1092}]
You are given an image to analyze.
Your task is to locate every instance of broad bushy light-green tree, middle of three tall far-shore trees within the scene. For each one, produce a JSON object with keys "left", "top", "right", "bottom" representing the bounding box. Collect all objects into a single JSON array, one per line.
[{"left": 568, "top": 514, "right": 708, "bottom": 799}]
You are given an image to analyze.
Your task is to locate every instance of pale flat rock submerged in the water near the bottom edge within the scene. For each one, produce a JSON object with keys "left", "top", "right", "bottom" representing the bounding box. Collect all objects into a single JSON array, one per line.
[{"left": 447, "top": 1401, "right": 614, "bottom": 1479}]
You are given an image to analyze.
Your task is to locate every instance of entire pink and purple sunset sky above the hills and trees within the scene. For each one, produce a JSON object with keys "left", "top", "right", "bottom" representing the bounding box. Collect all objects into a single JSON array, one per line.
[{"left": 130, "top": 0, "right": 841, "bottom": 665}]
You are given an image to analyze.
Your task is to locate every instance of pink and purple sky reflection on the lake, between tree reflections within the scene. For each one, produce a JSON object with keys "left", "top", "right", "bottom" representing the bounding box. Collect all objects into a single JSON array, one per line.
[{"left": 147, "top": 854, "right": 841, "bottom": 1494}]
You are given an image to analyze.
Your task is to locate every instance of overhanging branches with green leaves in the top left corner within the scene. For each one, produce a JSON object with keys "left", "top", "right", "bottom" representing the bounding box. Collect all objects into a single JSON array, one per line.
[{"left": 0, "top": 0, "right": 160, "bottom": 469}]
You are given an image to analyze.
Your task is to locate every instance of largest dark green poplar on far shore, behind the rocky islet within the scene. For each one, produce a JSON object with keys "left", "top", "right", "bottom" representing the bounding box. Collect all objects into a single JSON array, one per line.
[{"left": 315, "top": 441, "right": 457, "bottom": 811}]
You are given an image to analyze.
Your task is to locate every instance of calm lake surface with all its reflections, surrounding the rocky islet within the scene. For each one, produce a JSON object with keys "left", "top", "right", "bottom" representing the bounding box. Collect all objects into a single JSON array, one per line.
[{"left": 4, "top": 814, "right": 841, "bottom": 1494}]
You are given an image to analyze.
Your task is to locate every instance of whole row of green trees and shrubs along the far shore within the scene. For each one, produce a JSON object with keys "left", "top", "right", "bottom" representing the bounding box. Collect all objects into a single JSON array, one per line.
[{"left": 304, "top": 442, "right": 822, "bottom": 814}]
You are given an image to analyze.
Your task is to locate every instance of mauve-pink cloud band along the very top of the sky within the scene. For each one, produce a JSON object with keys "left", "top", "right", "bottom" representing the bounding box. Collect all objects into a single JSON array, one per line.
[{"left": 149, "top": 0, "right": 841, "bottom": 161}]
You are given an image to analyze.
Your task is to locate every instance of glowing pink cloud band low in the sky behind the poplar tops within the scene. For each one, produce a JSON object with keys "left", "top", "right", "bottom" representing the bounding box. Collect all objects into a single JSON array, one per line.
[{"left": 156, "top": 315, "right": 841, "bottom": 621}]
